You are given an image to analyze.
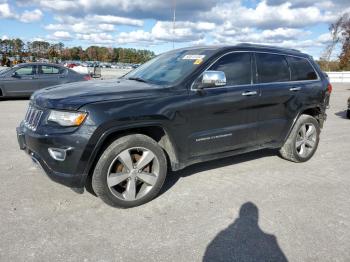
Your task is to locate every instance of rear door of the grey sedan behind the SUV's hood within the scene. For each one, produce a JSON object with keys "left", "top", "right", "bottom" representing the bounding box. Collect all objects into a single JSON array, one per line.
[{"left": 38, "top": 65, "right": 67, "bottom": 89}]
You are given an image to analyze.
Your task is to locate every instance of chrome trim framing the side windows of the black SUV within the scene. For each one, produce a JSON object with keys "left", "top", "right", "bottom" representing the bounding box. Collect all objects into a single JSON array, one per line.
[{"left": 190, "top": 51, "right": 321, "bottom": 92}]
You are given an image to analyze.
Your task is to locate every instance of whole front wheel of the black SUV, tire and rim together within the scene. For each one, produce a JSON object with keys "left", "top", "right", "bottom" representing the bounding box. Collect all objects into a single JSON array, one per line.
[{"left": 92, "top": 134, "right": 167, "bottom": 208}]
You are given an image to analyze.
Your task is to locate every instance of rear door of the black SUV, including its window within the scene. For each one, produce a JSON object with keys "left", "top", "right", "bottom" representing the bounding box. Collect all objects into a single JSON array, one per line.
[{"left": 255, "top": 52, "right": 303, "bottom": 144}]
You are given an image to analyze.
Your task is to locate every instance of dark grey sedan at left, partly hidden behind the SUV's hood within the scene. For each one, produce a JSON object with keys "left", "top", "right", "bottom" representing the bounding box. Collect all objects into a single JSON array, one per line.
[{"left": 0, "top": 63, "right": 91, "bottom": 97}]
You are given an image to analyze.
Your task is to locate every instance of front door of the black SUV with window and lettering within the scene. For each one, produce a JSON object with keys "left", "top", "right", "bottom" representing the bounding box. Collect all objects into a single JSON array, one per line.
[{"left": 189, "top": 52, "right": 259, "bottom": 157}]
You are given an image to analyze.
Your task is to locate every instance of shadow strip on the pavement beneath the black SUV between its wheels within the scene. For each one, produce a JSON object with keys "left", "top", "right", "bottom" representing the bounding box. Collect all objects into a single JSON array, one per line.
[{"left": 159, "top": 149, "right": 278, "bottom": 195}]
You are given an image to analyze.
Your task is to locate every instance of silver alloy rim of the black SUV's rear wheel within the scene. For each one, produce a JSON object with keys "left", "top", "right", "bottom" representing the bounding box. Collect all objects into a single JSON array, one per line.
[{"left": 295, "top": 123, "right": 317, "bottom": 158}]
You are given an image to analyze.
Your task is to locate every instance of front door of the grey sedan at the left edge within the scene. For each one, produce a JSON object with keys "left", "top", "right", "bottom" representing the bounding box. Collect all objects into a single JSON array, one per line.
[{"left": 2, "top": 65, "right": 39, "bottom": 96}]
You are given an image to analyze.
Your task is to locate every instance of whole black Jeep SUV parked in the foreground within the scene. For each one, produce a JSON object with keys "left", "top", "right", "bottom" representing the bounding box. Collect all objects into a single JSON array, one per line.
[{"left": 17, "top": 44, "right": 332, "bottom": 207}]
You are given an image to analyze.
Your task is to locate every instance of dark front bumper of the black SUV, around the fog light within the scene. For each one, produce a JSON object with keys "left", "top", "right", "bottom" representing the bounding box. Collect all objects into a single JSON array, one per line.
[{"left": 16, "top": 123, "right": 86, "bottom": 188}]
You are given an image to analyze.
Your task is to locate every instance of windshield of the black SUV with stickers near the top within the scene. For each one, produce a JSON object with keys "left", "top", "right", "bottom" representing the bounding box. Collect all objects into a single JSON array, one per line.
[{"left": 124, "top": 48, "right": 215, "bottom": 85}]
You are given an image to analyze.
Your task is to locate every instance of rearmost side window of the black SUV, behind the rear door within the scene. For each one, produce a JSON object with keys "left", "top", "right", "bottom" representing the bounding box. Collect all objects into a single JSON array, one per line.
[{"left": 287, "top": 56, "right": 317, "bottom": 81}]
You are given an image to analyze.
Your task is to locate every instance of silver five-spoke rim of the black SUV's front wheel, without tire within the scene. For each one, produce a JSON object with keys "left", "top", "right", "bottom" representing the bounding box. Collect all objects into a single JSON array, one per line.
[{"left": 107, "top": 147, "right": 159, "bottom": 201}]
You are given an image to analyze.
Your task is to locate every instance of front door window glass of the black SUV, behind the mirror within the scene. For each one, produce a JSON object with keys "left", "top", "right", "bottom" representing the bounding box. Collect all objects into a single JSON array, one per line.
[{"left": 208, "top": 53, "right": 252, "bottom": 86}]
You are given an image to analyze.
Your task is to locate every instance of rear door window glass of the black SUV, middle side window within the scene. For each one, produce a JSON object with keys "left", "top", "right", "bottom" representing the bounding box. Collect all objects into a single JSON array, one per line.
[{"left": 256, "top": 53, "right": 290, "bottom": 83}]
